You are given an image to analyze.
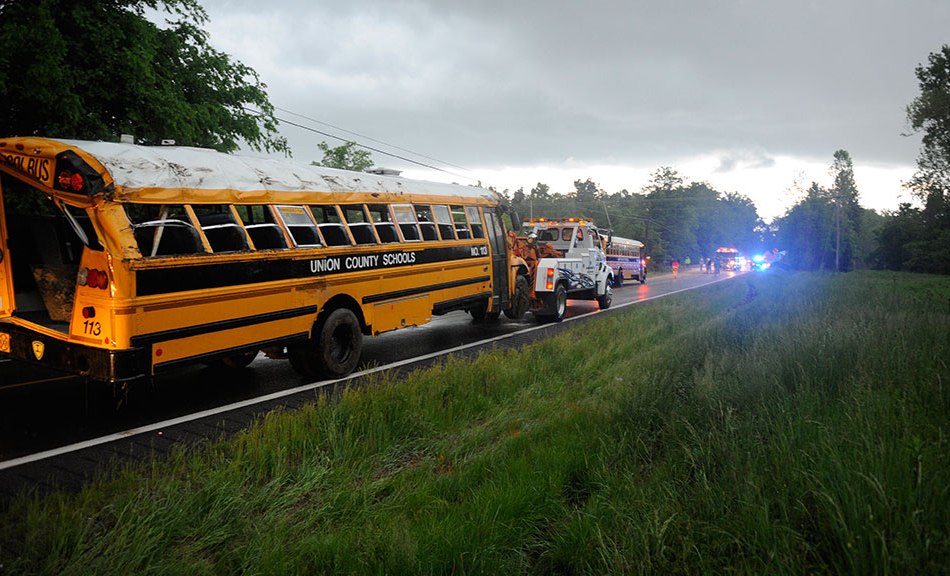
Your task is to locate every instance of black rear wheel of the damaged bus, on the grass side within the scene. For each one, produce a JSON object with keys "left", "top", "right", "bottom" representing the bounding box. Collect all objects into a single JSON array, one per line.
[{"left": 290, "top": 308, "right": 363, "bottom": 378}]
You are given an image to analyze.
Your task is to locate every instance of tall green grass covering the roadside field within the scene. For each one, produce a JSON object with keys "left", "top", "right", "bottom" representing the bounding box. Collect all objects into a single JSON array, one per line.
[{"left": 0, "top": 272, "right": 950, "bottom": 575}]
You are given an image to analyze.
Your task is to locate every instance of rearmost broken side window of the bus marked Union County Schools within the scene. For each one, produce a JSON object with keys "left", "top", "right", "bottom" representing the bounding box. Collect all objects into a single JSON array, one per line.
[{"left": 125, "top": 204, "right": 205, "bottom": 258}]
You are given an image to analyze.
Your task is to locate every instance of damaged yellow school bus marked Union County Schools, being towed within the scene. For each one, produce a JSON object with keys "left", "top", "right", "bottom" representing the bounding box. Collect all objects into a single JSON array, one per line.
[{"left": 0, "top": 138, "right": 524, "bottom": 383}]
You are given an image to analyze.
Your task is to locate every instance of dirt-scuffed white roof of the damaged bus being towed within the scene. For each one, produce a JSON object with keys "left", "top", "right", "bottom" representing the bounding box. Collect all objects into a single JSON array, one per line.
[{"left": 0, "top": 138, "right": 497, "bottom": 200}]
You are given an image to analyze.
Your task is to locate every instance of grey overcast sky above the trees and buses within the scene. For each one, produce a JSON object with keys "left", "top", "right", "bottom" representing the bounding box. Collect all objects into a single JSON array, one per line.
[{"left": 190, "top": 0, "right": 950, "bottom": 219}]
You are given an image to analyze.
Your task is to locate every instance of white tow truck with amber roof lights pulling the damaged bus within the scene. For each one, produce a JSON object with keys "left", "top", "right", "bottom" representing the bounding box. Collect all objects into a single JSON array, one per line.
[{"left": 517, "top": 218, "right": 613, "bottom": 322}]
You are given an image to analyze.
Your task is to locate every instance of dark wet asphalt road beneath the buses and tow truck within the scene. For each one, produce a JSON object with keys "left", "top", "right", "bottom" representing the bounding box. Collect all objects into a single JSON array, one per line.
[{"left": 0, "top": 269, "right": 735, "bottom": 465}]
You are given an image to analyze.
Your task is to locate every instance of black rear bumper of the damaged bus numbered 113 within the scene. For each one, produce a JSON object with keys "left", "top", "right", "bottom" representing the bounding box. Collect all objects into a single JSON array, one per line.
[{"left": 0, "top": 324, "right": 148, "bottom": 383}]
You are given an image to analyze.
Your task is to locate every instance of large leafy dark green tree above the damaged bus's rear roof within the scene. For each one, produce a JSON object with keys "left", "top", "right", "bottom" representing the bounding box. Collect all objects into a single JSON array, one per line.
[{"left": 0, "top": 0, "right": 289, "bottom": 154}]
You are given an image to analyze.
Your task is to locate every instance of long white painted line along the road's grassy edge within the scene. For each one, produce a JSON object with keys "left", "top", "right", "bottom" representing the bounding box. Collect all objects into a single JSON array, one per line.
[{"left": 0, "top": 277, "right": 728, "bottom": 470}]
